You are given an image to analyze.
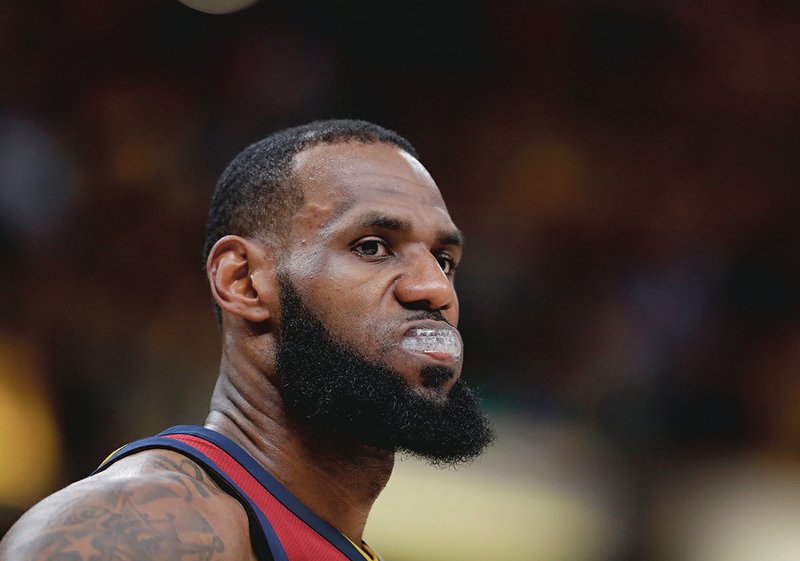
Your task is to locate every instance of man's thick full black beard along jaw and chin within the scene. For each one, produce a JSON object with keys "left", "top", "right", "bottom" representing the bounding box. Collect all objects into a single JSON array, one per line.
[{"left": 277, "top": 278, "right": 494, "bottom": 466}]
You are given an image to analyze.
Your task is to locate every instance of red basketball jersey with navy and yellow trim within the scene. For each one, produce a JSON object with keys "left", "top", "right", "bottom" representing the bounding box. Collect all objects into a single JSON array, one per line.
[{"left": 94, "top": 426, "right": 380, "bottom": 561}]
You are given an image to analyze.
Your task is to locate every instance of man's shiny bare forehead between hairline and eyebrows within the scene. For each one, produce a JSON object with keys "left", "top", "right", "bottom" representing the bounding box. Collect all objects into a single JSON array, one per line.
[{"left": 293, "top": 142, "right": 452, "bottom": 230}]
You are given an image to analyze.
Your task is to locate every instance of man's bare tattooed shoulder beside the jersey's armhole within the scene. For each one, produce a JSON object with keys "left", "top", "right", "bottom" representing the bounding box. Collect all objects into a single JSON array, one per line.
[{"left": 0, "top": 450, "right": 255, "bottom": 561}]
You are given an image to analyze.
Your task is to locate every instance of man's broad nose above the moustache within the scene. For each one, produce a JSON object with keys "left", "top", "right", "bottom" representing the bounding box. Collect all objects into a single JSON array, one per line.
[{"left": 394, "top": 252, "right": 457, "bottom": 311}]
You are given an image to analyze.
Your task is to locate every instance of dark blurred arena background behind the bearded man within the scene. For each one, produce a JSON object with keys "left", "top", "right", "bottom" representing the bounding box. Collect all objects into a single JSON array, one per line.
[{"left": 0, "top": 0, "right": 800, "bottom": 561}]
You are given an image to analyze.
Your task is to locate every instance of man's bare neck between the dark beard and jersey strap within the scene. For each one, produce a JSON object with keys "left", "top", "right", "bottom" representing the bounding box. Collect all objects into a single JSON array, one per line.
[{"left": 205, "top": 352, "right": 394, "bottom": 544}]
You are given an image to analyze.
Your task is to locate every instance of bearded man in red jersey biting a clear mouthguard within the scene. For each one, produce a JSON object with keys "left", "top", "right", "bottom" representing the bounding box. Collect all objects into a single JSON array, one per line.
[{"left": 0, "top": 121, "right": 492, "bottom": 561}]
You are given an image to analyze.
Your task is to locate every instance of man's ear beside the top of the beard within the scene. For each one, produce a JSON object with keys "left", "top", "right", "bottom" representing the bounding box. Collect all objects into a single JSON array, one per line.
[{"left": 206, "top": 236, "right": 278, "bottom": 323}]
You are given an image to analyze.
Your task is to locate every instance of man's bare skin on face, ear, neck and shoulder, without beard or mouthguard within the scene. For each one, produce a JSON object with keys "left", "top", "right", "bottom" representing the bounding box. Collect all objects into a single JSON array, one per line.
[{"left": 0, "top": 142, "right": 462, "bottom": 561}]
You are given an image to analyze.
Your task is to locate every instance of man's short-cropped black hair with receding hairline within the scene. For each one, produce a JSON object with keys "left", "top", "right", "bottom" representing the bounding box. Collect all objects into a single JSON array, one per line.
[{"left": 203, "top": 119, "right": 418, "bottom": 265}]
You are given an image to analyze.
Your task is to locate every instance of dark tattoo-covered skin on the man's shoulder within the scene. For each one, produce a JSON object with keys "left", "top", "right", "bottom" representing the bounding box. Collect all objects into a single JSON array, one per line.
[{"left": 2, "top": 453, "right": 231, "bottom": 561}]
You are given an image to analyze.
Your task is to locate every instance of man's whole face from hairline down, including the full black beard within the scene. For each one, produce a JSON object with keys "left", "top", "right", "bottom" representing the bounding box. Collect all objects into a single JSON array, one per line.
[{"left": 277, "top": 143, "right": 492, "bottom": 463}]
